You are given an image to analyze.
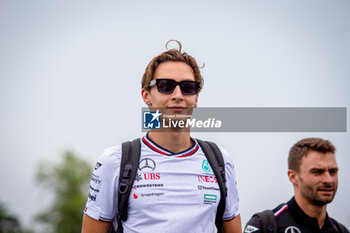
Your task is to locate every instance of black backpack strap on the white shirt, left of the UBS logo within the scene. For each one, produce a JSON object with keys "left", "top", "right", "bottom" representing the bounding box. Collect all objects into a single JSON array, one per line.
[{"left": 112, "top": 138, "right": 141, "bottom": 233}]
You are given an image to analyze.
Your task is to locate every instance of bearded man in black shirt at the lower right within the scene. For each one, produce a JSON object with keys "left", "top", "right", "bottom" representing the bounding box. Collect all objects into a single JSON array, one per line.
[{"left": 244, "top": 138, "right": 349, "bottom": 233}]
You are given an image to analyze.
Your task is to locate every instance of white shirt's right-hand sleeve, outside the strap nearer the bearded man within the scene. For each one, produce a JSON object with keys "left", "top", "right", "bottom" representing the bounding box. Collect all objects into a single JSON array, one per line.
[{"left": 220, "top": 147, "right": 240, "bottom": 221}]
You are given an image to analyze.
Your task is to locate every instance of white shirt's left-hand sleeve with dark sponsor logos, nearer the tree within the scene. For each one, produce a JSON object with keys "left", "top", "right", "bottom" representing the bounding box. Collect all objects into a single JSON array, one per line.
[{"left": 84, "top": 146, "right": 121, "bottom": 222}]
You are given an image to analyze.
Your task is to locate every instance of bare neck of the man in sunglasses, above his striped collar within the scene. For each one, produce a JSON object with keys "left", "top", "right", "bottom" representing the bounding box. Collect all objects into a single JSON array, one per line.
[{"left": 148, "top": 131, "right": 194, "bottom": 153}]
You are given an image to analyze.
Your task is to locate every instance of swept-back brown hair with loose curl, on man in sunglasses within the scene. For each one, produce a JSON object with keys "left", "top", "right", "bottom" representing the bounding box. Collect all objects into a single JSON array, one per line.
[{"left": 141, "top": 40, "right": 203, "bottom": 91}]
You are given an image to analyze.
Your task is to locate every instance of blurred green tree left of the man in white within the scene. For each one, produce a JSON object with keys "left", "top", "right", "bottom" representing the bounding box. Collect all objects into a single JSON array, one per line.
[{"left": 37, "top": 151, "right": 92, "bottom": 233}]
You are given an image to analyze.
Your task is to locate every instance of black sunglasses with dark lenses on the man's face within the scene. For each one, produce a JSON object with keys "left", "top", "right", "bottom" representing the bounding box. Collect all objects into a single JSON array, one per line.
[{"left": 148, "top": 79, "right": 200, "bottom": 95}]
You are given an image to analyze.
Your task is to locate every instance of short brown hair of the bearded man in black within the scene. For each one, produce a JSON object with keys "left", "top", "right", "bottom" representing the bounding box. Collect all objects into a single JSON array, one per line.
[{"left": 288, "top": 138, "right": 335, "bottom": 172}]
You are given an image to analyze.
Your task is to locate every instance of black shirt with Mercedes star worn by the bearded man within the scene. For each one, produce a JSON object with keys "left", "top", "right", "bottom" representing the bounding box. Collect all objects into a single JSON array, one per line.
[{"left": 244, "top": 197, "right": 349, "bottom": 233}]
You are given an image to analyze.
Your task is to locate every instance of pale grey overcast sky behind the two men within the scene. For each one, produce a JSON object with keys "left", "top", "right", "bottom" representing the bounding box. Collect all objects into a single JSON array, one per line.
[{"left": 0, "top": 0, "right": 350, "bottom": 228}]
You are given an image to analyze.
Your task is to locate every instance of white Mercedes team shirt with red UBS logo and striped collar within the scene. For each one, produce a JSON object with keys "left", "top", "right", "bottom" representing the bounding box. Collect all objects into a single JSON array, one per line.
[{"left": 85, "top": 135, "right": 239, "bottom": 233}]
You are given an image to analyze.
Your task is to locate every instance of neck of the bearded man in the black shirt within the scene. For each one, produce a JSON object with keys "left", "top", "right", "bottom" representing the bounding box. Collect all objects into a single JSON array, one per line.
[{"left": 295, "top": 193, "right": 327, "bottom": 229}]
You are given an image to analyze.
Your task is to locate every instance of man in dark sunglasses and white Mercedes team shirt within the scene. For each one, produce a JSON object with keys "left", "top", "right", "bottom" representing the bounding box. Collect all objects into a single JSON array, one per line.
[{"left": 82, "top": 42, "right": 241, "bottom": 233}]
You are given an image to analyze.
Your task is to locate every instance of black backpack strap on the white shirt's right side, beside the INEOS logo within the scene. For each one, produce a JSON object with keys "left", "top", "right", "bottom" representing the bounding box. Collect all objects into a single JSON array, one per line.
[{"left": 196, "top": 139, "right": 227, "bottom": 233}]
